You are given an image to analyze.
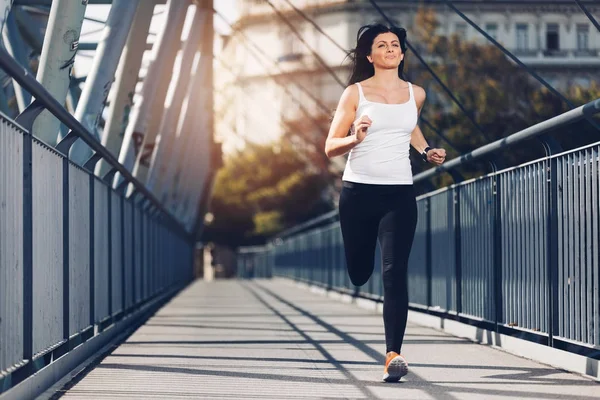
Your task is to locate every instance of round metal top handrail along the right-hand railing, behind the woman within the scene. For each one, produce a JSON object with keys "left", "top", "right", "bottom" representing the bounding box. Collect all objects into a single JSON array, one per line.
[{"left": 275, "top": 99, "right": 600, "bottom": 239}]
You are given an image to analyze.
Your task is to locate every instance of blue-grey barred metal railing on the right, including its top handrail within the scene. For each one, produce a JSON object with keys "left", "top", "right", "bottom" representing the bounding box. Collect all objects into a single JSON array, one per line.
[{"left": 239, "top": 99, "right": 600, "bottom": 359}]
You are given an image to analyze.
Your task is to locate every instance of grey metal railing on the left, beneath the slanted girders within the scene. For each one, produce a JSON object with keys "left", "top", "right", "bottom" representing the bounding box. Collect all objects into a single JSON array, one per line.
[{"left": 0, "top": 45, "right": 194, "bottom": 394}]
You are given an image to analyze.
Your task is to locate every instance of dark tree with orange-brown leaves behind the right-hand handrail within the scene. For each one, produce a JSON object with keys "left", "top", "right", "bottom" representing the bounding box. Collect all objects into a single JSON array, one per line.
[{"left": 408, "top": 8, "right": 600, "bottom": 186}]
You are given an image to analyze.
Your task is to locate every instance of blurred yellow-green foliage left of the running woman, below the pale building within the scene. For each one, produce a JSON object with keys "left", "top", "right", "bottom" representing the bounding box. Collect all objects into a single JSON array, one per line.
[{"left": 204, "top": 141, "right": 331, "bottom": 246}]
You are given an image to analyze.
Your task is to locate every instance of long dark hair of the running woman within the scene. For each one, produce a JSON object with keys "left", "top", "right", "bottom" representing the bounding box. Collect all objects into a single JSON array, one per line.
[{"left": 348, "top": 24, "right": 406, "bottom": 85}]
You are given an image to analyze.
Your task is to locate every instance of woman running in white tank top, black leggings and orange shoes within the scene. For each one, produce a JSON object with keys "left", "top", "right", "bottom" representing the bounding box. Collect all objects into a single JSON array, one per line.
[{"left": 325, "top": 24, "right": 446, "bottom": 382}]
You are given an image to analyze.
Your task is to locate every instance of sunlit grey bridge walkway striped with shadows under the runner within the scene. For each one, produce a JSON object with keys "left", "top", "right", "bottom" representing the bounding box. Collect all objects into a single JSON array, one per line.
[{"left": 56, "top": 280, "right": 600, "bottom": 400}]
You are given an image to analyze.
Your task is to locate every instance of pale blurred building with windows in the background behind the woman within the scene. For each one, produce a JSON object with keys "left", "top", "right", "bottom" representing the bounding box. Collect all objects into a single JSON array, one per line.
[{"left": 216, "top": 0, "right": 600, "bottom": 154}]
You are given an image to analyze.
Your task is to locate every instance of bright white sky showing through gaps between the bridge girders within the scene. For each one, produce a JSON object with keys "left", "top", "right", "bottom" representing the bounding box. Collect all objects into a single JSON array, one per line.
[{"left": 74, "top": 0, "right": 238, "bottom": 77}]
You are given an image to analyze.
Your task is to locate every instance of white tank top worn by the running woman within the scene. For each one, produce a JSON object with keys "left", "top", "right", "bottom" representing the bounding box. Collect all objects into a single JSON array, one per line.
[{"left": 342, "top": 82, "right": 418, "bottom": 185}]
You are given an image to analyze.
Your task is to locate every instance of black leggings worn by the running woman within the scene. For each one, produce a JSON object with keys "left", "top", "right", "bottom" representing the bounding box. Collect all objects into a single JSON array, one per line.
[{"left": 339, "top": 182, "right": 417, "bottom": 353}]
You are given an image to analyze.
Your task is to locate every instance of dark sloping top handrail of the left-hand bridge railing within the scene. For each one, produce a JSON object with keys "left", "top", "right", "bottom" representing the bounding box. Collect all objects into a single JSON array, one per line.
[{"left": 0, "top": 48, "right": 191, "bottom": 237}]
